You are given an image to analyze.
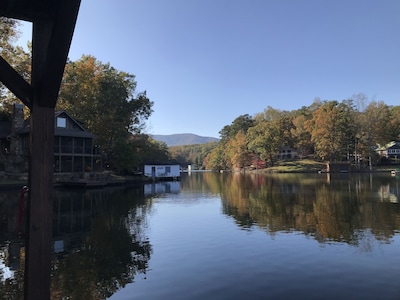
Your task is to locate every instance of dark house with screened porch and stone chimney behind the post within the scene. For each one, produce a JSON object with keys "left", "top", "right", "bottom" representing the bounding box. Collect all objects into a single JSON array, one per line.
[{"left": 0, "top": 104, "right": 102, "bottom": 173}]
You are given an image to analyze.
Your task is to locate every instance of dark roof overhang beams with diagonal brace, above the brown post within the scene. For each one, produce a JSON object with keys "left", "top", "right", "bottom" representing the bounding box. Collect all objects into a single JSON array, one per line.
[{"left": 0, "top": 0, "right": 81, "bottom": 108}]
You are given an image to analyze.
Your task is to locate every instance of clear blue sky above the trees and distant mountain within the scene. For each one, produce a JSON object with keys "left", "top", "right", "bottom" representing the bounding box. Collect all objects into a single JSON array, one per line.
[{"left": 17, "top": 0, "right": 400, "bottom": 137}]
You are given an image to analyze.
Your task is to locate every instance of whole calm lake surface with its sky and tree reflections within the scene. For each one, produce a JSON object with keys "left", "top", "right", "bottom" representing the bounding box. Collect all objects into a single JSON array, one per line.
[{"left": 0, "top": 172, "right": 400, "bottom": 300}]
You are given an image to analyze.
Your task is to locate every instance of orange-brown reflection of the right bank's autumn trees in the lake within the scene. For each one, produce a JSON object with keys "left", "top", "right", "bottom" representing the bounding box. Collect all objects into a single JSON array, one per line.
[{"left": 188, "top": 173, "right": 400, "bottom": 248}]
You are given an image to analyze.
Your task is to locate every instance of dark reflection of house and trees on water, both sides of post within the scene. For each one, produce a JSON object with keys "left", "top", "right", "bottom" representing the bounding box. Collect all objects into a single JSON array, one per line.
[{"left": 0, "top": 186, "right": 152, "bottom": 299}]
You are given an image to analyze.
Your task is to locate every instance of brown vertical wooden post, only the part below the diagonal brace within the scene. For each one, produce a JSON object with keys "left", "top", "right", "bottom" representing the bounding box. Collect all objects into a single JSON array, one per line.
[{"left": 25, "top": 101, "right": 54, "bottom": 299}]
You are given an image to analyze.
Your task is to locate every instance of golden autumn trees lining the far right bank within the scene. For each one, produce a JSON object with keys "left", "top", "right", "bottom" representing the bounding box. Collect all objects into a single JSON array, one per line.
[{"left": 204, "top": 94, "right": 400, "bottom": 170}]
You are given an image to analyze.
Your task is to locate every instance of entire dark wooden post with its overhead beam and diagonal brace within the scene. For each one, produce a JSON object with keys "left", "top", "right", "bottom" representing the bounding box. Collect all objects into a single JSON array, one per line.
[{"left": 0, "top": 0, "right": 81, "bottom": 300}]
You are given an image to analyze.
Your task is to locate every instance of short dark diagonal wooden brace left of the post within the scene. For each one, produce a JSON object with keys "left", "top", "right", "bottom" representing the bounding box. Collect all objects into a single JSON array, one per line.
[{"left": 0, "top": 56, "right": 32, "bottom": 107}]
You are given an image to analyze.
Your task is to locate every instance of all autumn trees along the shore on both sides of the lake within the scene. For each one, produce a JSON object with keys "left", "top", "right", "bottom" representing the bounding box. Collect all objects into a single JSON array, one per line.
[{"left": 0, "top": 18, "right": 400, "bottom": 173}]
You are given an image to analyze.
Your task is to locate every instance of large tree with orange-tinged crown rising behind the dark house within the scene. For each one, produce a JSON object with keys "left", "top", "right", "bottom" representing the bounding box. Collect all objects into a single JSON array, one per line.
[{"left": 57, "top": 56, "right": 153, "bottom": 169}]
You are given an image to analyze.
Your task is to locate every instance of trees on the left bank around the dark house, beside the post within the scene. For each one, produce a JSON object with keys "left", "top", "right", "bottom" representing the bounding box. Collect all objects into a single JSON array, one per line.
[{"left": 0, "top": 17, "right": 170, "bottom": 173}]
